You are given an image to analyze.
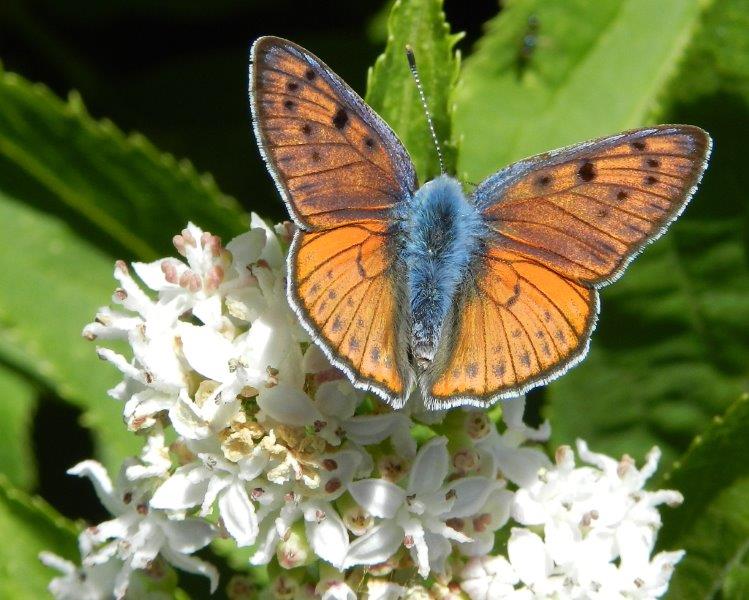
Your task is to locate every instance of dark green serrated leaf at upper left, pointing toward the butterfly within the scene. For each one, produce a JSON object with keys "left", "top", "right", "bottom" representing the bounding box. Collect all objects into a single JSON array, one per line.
[{"left": 0, "top": 66, "right": 247, "bottom": 260}]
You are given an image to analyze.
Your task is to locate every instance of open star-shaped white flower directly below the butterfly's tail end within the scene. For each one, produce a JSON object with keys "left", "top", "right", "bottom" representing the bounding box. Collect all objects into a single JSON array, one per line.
[{"left": 345, "top": 437, "right": 495, "bottom": 577}]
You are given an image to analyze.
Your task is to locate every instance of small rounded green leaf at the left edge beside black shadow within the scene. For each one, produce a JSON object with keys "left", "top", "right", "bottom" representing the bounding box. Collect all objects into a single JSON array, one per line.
[{"left": 0, "top": 366, "right": 37, "bottom": 490}]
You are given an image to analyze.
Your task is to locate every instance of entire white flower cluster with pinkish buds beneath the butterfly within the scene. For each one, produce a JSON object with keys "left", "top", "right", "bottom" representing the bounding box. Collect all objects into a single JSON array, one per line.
[{"left": 42, "top": 221, "right": 682, "bottom": 600}]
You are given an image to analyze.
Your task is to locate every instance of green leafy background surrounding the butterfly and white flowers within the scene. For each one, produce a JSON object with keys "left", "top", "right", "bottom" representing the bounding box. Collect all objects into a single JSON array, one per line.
[{"left": 0, "top": 0, "right": 749, "bottom": 597}]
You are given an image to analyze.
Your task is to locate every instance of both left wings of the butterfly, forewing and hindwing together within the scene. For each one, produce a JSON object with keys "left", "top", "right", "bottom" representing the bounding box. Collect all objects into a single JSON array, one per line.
[{"left": 250, "top": 37, "right": 417, "bottom": 405}]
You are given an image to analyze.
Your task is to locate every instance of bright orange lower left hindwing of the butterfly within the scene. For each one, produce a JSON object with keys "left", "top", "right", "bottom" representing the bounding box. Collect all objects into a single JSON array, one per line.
[{"left": 289, "top": 223, "right": 409, "bottom": 404}]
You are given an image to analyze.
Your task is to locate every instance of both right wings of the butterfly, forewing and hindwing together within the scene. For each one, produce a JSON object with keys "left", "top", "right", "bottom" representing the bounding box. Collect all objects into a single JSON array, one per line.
[{"left": 422, "top": 125, "right": 710, "bottom": 406}]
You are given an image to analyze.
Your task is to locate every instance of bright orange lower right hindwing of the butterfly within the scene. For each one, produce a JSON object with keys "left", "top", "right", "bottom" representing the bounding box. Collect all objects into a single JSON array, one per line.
[{"left": 422, "top": 246, "right": 598, "bottom": 407}]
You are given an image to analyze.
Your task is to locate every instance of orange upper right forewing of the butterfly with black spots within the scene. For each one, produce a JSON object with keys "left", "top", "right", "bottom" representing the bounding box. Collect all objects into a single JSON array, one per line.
[{"left": 475, "top": 125, "right": 710, "bottom": 285}]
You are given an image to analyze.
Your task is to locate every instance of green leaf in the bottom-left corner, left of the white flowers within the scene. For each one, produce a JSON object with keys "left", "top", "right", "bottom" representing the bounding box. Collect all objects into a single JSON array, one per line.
[{"left": 0, "top": 476, "right": 79, "bottom": 600}]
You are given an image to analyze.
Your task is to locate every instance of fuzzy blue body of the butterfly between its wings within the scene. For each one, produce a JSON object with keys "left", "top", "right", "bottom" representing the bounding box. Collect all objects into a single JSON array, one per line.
[{"left": 404, "top": 175, "right": 484, "bottom": 368}]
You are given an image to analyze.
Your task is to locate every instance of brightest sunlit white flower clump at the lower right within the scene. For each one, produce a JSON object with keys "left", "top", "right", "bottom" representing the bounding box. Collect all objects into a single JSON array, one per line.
[{"left": 461, "top": 441, "right": 683, "bottom": 599}]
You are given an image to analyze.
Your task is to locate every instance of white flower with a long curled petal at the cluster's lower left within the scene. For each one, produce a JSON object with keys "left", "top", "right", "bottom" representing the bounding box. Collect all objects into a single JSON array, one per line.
[{"left": 68, "top": 460, "right": 218, "bottom": 598}]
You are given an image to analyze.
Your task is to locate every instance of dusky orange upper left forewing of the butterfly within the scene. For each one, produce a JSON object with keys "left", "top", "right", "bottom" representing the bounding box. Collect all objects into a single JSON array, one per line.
[{"left": 250, "top": 37, "right": 417, "bottom": 229}]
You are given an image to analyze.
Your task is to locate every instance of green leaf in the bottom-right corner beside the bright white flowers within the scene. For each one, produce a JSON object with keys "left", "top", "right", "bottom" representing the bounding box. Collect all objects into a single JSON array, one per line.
[{"left": 666, "top": 477, "right": 749, "bottom": 600}]
